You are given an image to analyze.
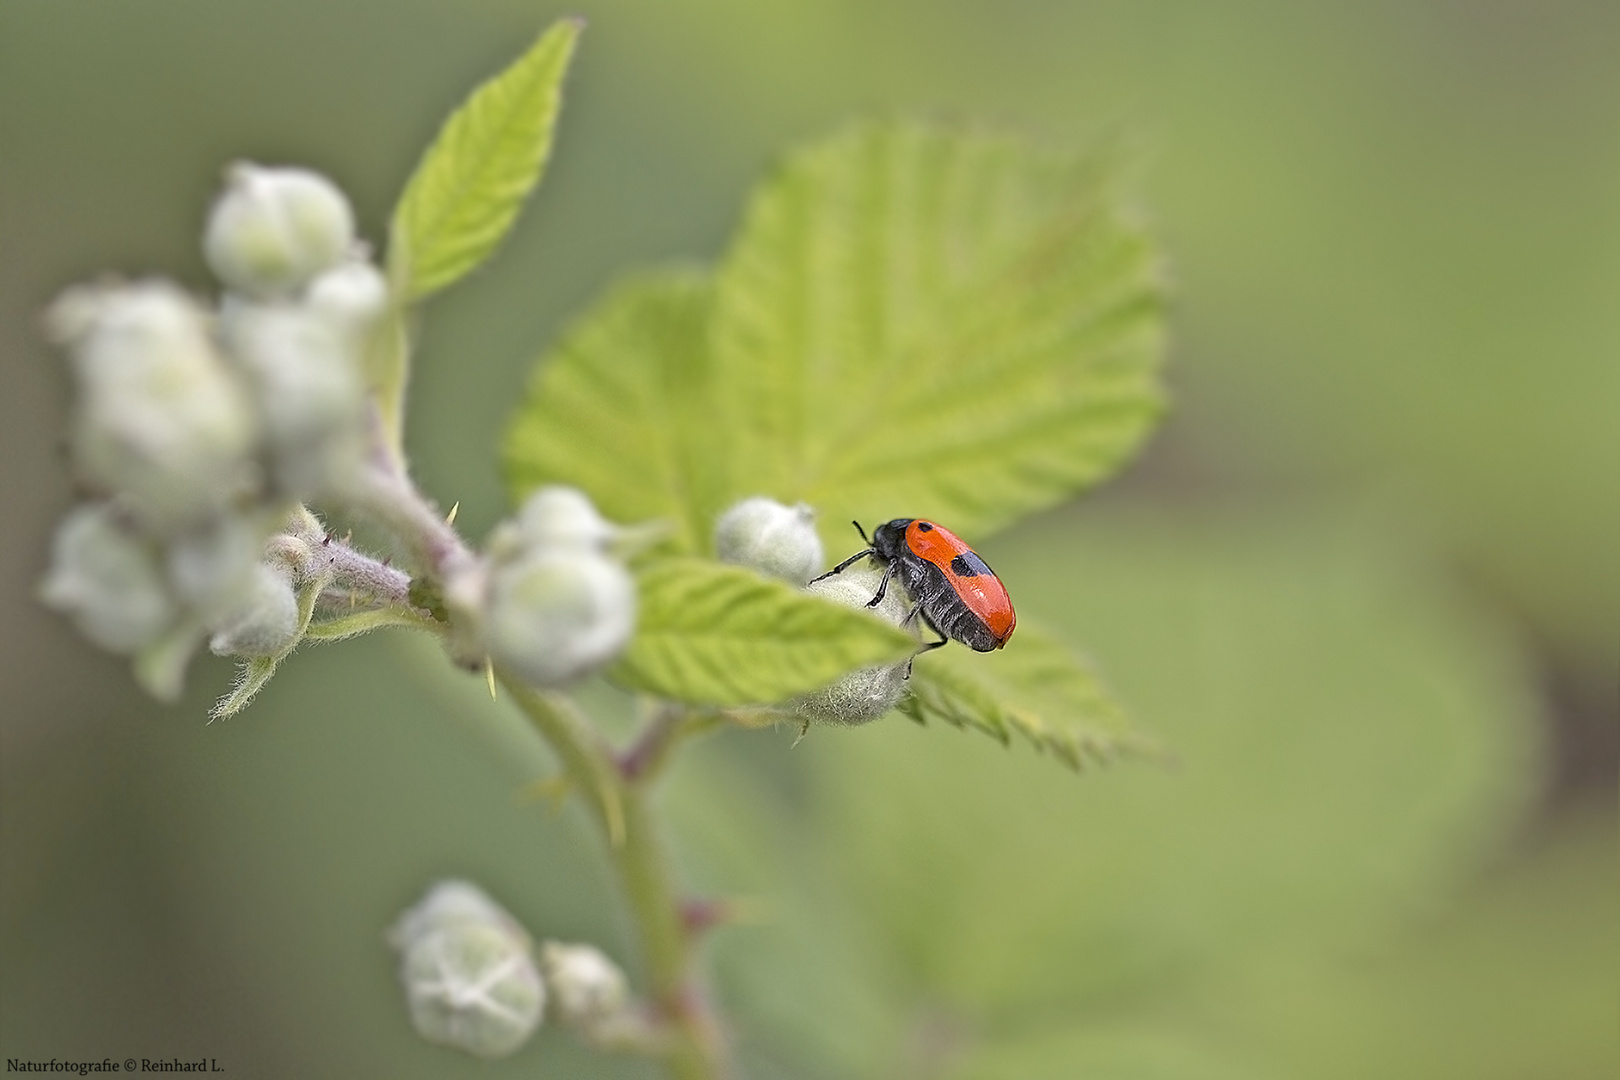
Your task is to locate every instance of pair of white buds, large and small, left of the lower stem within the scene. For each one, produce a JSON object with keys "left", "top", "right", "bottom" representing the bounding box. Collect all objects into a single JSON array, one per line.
[{"left": 389, "top": 881, "right": 650, "bottom": 1057}]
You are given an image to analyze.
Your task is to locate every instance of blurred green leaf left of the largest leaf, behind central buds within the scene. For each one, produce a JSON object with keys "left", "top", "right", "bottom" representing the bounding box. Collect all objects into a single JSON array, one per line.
[{"left": 504, "top": 272, "right": 723, "bottom": 552}]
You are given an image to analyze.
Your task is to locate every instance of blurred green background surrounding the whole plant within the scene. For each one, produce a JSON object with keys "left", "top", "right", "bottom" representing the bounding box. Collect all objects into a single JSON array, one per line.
[{"left": 0, "top": 0, "right": 1620, "bottom": 1080}]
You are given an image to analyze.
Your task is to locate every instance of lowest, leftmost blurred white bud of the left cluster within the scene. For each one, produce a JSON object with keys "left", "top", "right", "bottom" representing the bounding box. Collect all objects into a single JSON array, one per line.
[{"left": 39, "top": 504, "right": 178, "bottom": 653}]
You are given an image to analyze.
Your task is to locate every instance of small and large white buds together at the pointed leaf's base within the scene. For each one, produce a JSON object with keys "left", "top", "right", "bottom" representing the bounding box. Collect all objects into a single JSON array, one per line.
[{"left": 463, "top": 487, "right": 635, "bottom": 687}]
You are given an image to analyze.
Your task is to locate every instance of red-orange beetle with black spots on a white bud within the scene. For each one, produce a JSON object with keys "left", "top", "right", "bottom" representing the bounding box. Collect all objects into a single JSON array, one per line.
[{"left": 816, "top": 518, "right": 1017, "bottom": 653}]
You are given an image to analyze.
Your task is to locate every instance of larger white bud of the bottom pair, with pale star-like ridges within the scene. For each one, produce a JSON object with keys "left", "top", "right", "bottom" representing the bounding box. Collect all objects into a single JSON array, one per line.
[{"left": 389, "top": 881, "right": 546, "bottom": 1057}]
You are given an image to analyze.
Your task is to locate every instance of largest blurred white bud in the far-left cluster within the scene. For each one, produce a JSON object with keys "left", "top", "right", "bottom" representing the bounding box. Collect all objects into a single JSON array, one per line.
[{"left": 47, "top": 282, "right": 258, "bottom": 531}]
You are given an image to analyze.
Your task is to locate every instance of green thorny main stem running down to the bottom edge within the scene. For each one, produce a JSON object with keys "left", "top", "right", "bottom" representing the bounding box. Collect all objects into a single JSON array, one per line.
[{"left": 497, "top": 672, "right": 727, "bottom": 1080}]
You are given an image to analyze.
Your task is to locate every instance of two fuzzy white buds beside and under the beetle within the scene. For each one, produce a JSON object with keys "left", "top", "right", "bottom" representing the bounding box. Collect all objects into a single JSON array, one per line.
[{"left": 714, "top": 497, "right": 915, "bottom": 724}]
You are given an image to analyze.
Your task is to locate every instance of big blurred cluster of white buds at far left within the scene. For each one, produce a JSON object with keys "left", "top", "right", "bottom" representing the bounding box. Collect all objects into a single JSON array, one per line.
[{"left": 41, "top": 164, "right": 389, "bottom": 698}]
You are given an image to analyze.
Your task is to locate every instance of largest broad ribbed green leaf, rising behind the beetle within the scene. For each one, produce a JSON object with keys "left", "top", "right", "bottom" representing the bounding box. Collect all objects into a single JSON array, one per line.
[{"left": 710, "top": 123, "right": 1163, "bottom": 550}]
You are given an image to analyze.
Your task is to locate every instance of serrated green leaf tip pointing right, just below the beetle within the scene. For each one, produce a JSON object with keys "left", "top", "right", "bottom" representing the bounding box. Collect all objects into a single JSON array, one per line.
[{"left": 899, "top": 619, "right": 1158, "bottom": 769}]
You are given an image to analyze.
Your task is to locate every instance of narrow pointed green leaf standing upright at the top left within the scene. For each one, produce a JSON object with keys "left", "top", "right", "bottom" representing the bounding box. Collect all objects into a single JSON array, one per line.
[{"left": 389, "top": 19, "right": 583, "bottom": 301}]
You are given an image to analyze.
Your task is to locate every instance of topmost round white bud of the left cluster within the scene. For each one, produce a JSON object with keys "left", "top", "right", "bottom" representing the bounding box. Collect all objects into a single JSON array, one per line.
[{"left": 203, "top": 162, "right": 355, "bottom": 298}]
